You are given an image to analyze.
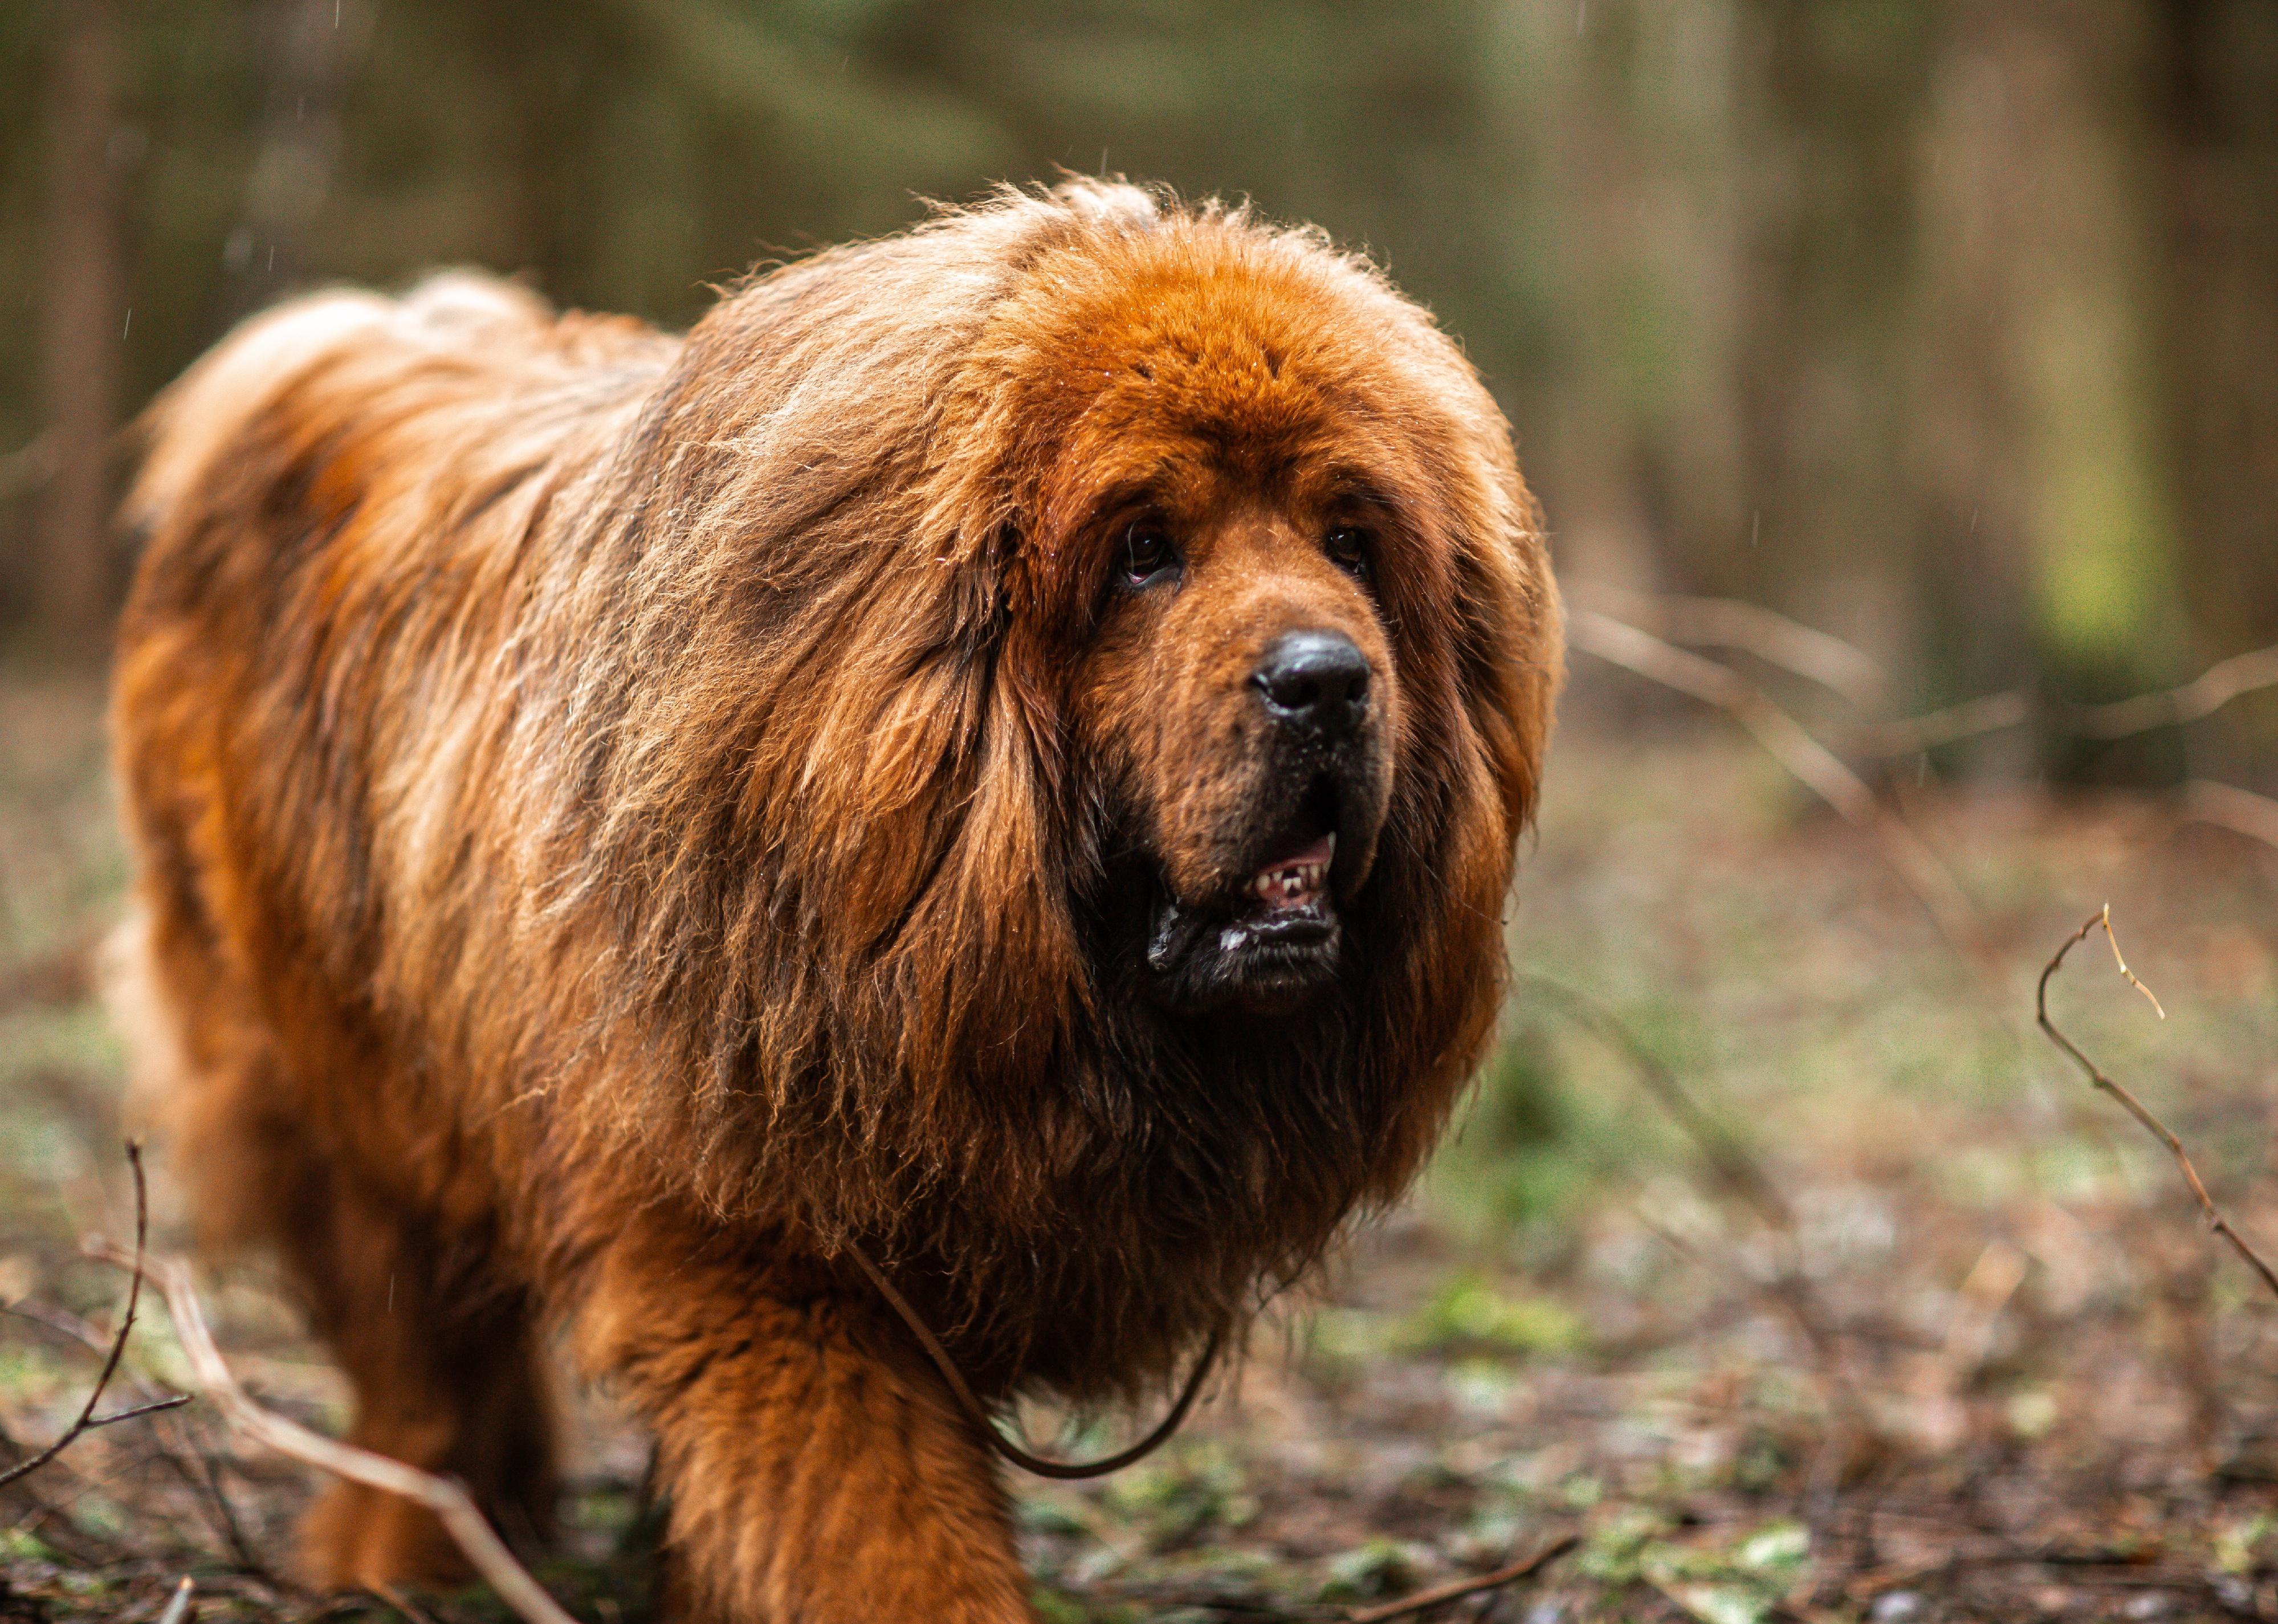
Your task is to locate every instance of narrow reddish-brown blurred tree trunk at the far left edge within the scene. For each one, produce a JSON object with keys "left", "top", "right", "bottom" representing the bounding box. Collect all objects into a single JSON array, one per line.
[{"left": 34, "top": 0, "right": 128, "bottom": 660}]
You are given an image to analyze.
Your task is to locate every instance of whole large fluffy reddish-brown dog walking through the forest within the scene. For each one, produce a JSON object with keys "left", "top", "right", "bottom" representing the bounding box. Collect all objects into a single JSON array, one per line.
[{"left": 116, "top": 182, "right": 1560, "bottom": 1624}]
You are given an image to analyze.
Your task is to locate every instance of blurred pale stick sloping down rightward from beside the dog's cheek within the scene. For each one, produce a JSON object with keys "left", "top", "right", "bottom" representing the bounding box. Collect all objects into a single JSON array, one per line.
[{"left": 1567, "top": 608, "right": 1991, "bottom": 961}]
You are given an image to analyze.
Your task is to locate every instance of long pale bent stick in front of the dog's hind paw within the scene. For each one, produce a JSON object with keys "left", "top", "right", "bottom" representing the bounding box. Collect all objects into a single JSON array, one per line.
[{"left": 87, "top": 1239, "right": 574, "bottom": 1624}]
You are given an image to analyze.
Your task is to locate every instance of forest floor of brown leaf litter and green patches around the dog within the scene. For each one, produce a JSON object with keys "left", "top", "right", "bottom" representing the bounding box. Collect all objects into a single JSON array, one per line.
[{"left": 0, "top": 681, "right": 2278, "bottom": 1624}]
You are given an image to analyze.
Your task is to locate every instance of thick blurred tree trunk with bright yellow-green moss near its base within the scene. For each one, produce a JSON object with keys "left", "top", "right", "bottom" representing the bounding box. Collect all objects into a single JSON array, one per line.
[{"left": 1916, "top": 0, "right": 2182, "bottom": 781}]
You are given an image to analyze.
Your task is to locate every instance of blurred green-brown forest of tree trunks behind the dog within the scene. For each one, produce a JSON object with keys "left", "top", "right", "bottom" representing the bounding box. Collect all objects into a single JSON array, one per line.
[{"left": 0, "top": 0, "right": 2278, "bottom": 781}]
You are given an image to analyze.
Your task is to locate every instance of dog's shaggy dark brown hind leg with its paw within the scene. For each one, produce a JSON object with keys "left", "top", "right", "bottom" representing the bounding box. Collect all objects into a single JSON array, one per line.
[{"left": 109, "top": 906, "right": 553, "bottom": 1590}]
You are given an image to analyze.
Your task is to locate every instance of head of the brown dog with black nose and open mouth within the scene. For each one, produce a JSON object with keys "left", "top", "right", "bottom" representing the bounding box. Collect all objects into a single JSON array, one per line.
[{"left": 934, "top": 190, "right": 1556, "bottom": 1016}]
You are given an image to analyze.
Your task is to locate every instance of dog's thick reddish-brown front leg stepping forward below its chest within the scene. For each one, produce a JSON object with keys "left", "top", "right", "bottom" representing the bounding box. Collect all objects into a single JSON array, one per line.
[{"left": 581, "top": 1234, "right": 1034, "bottom": 1624}]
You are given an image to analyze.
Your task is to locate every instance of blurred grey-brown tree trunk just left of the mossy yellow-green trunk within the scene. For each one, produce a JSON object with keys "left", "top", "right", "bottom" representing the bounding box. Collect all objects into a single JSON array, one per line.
[{"left": 1731, "top": 0, "right": 1936, "bottom": 676}]
